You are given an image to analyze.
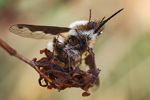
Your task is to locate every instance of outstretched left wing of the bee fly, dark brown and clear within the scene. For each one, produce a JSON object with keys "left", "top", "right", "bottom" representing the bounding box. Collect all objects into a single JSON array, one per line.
[{"left": 9, "top": 24, "right": 70, "bottom": 39}]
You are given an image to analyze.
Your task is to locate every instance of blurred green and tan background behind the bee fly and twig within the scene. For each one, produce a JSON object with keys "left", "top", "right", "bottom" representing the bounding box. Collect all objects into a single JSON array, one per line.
[{"left": 0, "top": 0, "right": 150, "bottom": 100}]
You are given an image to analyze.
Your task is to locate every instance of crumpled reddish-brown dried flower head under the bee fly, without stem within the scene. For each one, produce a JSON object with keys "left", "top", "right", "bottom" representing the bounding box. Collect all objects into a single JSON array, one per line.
[{"left": 35, "top": 49, "right": 100, "bottom": 96}]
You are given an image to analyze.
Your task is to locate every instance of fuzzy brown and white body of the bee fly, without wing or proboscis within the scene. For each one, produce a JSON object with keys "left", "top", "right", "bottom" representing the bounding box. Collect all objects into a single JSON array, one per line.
[{"left": 51, "top": 21, "right": 103, "bottom": 66}]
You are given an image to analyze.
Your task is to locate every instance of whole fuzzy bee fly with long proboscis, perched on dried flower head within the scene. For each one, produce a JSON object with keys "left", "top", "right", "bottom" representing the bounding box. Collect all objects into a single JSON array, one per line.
[{"left": 10, "top": 8, "right": 123, "bottom": 69}]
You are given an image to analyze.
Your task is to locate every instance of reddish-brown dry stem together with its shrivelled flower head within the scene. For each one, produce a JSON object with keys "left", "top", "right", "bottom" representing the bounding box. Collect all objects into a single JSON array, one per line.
[{"left": 0, "top": 39, "right": 100, "bottom": 96}]
